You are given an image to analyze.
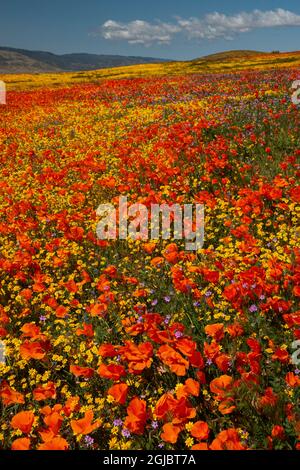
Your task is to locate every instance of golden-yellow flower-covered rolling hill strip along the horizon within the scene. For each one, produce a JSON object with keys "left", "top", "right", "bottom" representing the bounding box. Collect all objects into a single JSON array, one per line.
[{"left": 0, "top": 51, "right": 300, "bottom": 90}]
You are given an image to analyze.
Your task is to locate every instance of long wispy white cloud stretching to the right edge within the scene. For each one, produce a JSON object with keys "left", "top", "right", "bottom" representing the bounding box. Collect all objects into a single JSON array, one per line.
[{"left": 100, "top": 8, "right": 300, "bottom": 46}]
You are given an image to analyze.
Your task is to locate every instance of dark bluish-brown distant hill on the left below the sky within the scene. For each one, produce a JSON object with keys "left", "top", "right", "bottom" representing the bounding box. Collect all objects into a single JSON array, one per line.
[{"left": 0, "top": 47, "right": 168, "bottom": 74}]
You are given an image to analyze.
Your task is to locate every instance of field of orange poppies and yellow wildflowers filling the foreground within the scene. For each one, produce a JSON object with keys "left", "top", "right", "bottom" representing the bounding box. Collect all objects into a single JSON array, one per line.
[{"left": 0, "top": 57, "right": 300, "bottom": 450}]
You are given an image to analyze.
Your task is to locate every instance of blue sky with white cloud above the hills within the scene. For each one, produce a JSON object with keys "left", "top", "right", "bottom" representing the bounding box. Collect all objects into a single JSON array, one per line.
[{"left": 0, "top": 0, "right": 300, "bottom": 59}]
